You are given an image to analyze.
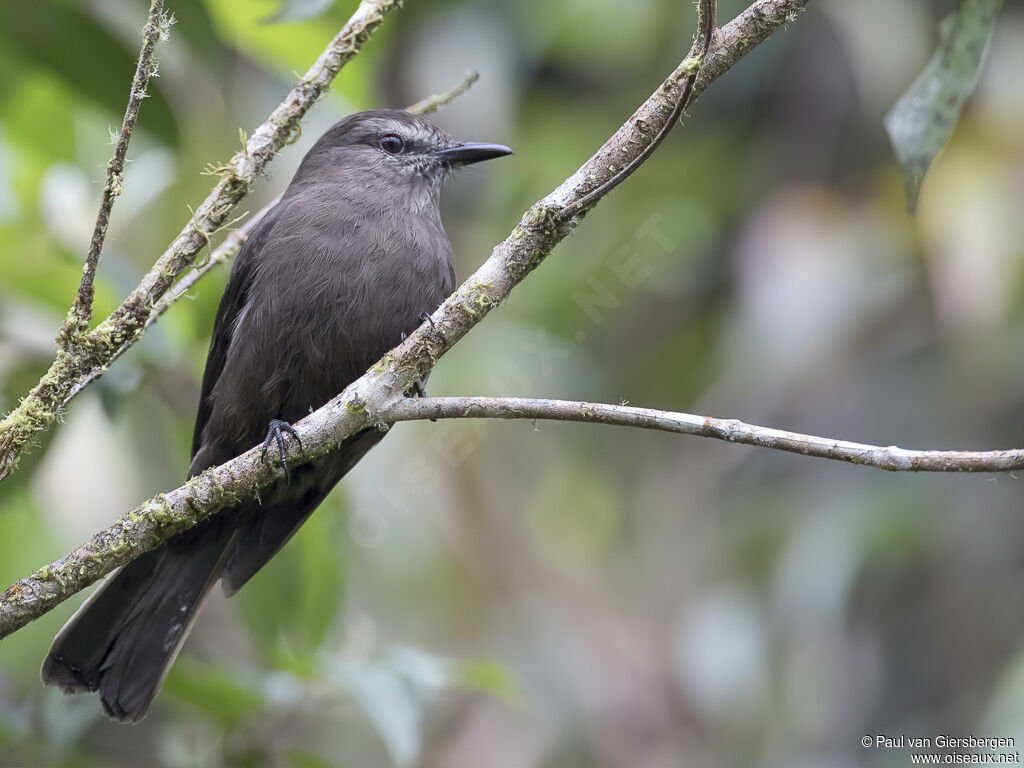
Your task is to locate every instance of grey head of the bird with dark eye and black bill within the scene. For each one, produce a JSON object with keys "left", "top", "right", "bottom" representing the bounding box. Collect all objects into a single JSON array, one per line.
[{"left": 295, "top": 110, "right": 512, "bottom": 198}]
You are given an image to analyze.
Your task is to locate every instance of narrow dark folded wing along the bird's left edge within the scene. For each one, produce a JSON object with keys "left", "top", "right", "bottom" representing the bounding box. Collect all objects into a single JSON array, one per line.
[{"left": 188, "top": 206, "right": 280, "bottom": 466}]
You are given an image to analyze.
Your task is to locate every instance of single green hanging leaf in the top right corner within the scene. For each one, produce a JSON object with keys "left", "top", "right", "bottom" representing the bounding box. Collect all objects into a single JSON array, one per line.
[{"left": 886, "top": 0, "right": 1002, "bottom": 213}]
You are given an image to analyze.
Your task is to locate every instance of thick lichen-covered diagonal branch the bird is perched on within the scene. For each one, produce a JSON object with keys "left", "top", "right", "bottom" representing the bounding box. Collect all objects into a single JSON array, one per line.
[{"left": 0, "top": 0, "right": 819, "bottom": 637}]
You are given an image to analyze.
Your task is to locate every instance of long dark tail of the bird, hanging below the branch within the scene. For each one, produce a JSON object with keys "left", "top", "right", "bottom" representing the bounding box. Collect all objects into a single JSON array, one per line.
[{"left": 42, "top": 525, "right": 234, "bottom": 722}]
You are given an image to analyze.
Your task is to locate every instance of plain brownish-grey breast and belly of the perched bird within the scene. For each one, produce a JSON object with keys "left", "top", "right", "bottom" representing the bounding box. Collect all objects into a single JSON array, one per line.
[{"left": 245, "top": 205, "right": 454, "bottom": 415}]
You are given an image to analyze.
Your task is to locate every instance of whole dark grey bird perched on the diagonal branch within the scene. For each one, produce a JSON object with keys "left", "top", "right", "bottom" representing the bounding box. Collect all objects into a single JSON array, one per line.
[{"left": 42, "top": 110, "right": 512, "bottom": 721}]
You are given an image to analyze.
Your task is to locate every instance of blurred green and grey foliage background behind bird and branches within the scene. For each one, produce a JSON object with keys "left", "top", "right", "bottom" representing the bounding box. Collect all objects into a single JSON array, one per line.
[{"left": 0, "top": 0, "right": 1024, "bottom": 768}]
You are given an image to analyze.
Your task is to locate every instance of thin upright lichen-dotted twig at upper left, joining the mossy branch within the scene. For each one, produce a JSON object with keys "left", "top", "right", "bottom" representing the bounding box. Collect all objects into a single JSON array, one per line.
[{"left": 65, "top": 0, "right": 165, "bottom": 335}]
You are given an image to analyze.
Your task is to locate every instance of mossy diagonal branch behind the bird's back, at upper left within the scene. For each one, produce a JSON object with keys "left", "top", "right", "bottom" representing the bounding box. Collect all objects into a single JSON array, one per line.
[{"left": 0, "top": 0, "right": 400, "bottom": 481}]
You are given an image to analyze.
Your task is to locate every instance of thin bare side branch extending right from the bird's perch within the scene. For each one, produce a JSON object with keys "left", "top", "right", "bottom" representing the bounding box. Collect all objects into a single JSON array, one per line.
[{"left": 380, "top": 397, "right": 1024, "bottom": 472}]
